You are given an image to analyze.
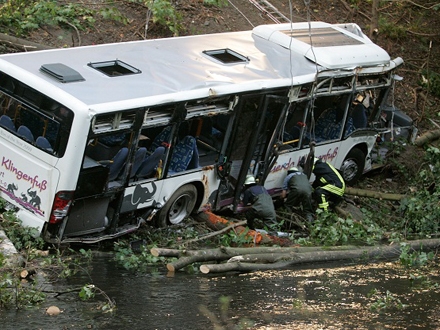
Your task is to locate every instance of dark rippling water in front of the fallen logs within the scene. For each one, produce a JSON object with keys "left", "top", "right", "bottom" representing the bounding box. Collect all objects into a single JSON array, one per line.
[{"left": 0, "top": 251, "right": 440, "bottom": 330}]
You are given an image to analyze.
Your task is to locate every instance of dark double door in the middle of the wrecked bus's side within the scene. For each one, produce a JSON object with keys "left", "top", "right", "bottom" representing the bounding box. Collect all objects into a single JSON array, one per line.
[{"left": 216, "top": 94, "right": 288, "bottom": 211}]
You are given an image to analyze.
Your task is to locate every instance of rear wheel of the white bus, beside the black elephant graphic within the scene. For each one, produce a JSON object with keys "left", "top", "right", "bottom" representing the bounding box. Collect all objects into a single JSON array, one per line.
[{"left": 157, "top": 184, "right": 197, "bottom": 227}]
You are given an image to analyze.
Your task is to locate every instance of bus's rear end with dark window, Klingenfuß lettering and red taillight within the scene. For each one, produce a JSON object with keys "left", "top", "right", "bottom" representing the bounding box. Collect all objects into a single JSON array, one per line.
[{"left": 0, "top": 84, "right": 73, "bottom": 232}]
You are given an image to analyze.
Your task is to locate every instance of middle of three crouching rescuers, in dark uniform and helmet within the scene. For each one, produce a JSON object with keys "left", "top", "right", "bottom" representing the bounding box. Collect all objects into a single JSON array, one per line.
[{"left": 281, "top": 166, "right": 314, "bottom": 222}]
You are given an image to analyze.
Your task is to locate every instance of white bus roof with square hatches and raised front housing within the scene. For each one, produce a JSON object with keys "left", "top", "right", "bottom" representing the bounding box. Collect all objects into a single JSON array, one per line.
[{"left": 0, "top": 22, "right": 392, "bottom": 111}]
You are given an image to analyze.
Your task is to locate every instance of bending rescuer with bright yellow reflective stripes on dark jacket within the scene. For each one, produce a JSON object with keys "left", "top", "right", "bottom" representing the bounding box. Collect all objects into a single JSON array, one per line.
[{"left": 312, "top": 158, "right": 345, "bottom": 212}]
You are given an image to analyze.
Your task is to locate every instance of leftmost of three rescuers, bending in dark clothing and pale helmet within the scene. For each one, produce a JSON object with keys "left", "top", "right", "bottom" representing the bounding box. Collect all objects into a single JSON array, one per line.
[{"left": 243, "top": 175, "right": 277, "bottom": 231}]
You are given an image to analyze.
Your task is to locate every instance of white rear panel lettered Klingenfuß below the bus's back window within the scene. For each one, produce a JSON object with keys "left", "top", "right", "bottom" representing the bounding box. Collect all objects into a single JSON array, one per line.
[{"left": 0, "top": 129, "right": 60, "bottom": 229}]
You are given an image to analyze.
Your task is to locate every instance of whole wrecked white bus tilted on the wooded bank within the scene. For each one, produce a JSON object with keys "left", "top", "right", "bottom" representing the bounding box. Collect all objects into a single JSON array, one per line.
[{"left": 0, "top": 22, "right": 410, "bottom": 243}]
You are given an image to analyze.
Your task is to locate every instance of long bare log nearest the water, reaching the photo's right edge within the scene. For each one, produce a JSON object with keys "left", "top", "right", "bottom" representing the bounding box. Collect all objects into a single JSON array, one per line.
[{"left": 200, "top": 239, "right": 440, "bottom": 274}]
